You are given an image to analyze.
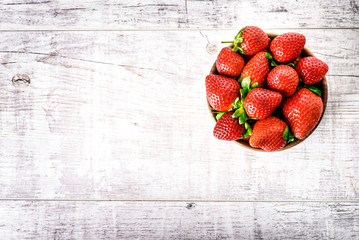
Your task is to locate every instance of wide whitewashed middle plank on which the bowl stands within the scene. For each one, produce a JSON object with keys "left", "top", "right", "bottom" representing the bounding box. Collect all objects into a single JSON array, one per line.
[{"left": 0, "top": 30, "right": 359, "bottom": 200}]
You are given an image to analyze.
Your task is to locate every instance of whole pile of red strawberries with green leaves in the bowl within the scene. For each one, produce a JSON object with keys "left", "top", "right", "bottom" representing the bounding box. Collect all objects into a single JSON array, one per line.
[{"left": 206, "top": 26, "right": 328, "bottom": 151}]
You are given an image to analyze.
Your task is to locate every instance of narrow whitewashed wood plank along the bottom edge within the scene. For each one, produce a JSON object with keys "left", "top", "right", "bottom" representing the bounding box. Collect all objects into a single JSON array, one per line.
[{"left": 0, "top": 201, "right": 359, "bottom": 240}]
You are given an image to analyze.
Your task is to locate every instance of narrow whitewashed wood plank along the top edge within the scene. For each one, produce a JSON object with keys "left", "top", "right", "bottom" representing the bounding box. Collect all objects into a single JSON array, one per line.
[{"left": 0, "top": 0, "right": 359, "bottom": 29}]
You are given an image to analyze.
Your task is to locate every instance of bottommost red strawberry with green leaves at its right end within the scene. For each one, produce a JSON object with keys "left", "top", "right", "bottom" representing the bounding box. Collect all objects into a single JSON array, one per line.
[{"left": 249, "top": 116, "right": 288, "bottom": 151}]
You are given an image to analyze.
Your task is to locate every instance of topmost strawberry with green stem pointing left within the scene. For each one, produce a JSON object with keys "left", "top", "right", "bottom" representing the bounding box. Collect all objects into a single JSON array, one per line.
[{"left": 223, "top": 26, "right": 269, "bottom": 55}]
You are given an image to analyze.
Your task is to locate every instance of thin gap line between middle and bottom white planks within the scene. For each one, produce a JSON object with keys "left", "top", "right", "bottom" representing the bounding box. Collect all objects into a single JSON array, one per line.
[{"left": 0, "top": 198, "right": 359, "bottom": 203}]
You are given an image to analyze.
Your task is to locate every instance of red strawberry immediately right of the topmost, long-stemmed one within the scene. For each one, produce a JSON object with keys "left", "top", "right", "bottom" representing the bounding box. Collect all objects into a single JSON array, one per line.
[{"left": 270, "top": 32, "right": 305, "bottom": 63}]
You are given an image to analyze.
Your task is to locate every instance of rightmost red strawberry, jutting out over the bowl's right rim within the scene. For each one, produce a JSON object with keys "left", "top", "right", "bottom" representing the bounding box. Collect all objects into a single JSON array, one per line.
[{"left": 295, "top": 57, "right": 329, "bottom": 85}]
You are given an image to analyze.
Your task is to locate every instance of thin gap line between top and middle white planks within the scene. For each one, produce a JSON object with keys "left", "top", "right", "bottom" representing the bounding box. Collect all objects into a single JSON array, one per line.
[{"left": 0, "top": 27, "right": 359, "bottom": 32}]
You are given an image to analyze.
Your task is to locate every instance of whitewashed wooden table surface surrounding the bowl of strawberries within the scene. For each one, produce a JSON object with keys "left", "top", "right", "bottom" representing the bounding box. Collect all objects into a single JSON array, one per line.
[{"left": 0, "top": 0, "right": 359, "bottom": 240}]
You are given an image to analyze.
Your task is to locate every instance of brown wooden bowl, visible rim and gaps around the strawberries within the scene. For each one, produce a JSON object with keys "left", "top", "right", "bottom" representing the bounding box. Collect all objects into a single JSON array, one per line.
[{"left": 207, "top": 33, "right": 328, "bottom": 152}]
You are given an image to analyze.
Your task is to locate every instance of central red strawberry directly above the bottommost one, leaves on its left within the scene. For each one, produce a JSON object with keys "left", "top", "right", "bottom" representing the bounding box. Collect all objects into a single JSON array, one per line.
[{"left": 243, "top": 88, "right": 282, "bottom": 119}]
